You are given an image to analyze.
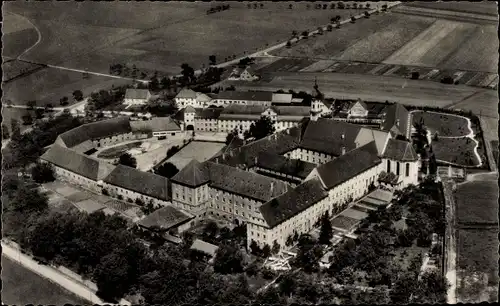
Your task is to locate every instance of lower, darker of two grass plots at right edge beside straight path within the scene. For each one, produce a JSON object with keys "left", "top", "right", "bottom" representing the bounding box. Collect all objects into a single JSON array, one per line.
[{"left": 458, "top": 229, "right": 498, "bottom": 285}]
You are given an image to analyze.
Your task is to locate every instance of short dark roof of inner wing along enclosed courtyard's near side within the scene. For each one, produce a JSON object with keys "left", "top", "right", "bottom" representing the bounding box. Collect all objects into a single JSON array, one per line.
[{"left": 255, "top": 152, "right": 316, "bottom": 179}]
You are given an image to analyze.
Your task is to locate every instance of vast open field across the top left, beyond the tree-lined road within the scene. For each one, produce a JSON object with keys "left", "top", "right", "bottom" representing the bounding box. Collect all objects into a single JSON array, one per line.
[{"left": 0, "top": 2, "right": 376, "bottom": 74}]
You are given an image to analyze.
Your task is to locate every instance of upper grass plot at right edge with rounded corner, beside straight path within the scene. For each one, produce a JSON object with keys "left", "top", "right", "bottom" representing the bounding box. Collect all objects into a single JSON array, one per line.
[{"left": 455, "top": 180, "right": 498, "bottom": 223}]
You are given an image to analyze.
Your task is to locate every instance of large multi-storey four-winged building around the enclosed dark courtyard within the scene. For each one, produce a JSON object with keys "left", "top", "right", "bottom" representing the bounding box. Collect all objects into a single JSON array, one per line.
[{"left": 171, "top": 118, "right": 419, "bottom": 247}]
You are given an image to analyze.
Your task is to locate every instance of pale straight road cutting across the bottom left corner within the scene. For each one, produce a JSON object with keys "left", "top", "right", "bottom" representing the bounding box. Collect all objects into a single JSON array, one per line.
[{"left": 2, "top": 240, "right": 130, "bottom": 305}]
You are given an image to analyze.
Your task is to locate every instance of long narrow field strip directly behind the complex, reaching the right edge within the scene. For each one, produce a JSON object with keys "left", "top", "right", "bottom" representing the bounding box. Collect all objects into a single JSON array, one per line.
[{"left": 225, "top": 72, "right": 498, "bottom": 109}]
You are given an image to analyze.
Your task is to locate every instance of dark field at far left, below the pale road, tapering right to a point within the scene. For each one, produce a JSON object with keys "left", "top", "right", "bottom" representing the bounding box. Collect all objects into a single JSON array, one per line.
[{"left": 2, "top": 68, "right": 131, "bottom": 107}]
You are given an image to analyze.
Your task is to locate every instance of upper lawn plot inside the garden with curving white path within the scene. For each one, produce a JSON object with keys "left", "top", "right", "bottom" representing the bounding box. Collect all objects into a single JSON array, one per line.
[{"left": 412, "top": 111, "right": 470, "bottom": 137}]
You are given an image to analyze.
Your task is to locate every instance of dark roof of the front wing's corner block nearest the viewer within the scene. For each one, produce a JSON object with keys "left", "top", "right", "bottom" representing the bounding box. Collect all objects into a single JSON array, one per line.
[{"left": 259, "top": 178, "right": 328, "bottom": 228}]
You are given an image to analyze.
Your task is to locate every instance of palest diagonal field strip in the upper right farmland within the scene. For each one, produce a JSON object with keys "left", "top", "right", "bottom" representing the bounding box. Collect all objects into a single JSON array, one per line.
[{"left": 383, "top": 20, "right": 460, "bottom": 66}]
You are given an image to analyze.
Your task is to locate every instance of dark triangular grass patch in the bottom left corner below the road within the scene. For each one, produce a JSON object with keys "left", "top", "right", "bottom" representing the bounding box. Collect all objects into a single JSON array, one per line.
[{"left": 2, "top": 256, "right": 89, "bottom": 305}]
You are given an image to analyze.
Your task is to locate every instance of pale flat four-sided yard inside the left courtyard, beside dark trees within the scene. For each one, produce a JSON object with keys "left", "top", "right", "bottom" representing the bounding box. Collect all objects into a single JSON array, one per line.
[{"left": 167, "top": 141, "right": 224, "bottom": 170}]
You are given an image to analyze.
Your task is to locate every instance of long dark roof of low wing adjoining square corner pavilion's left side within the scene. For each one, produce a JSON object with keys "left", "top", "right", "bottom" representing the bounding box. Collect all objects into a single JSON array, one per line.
[{"left": 103, "top": 165, "right": 170, "bottom": 200}]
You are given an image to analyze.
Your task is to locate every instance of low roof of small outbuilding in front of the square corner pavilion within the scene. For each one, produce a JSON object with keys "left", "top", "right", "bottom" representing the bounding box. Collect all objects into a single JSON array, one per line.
[{"left": 138, "top": 205, "right": 194, "bottom": 230}]
